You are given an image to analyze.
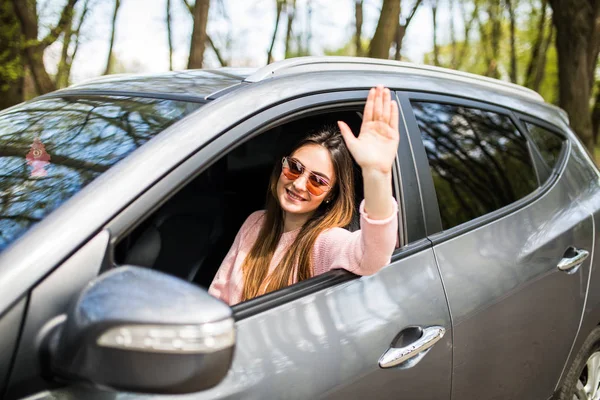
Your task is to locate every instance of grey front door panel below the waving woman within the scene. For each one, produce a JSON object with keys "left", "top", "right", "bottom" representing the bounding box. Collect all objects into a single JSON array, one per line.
[{"left": 29, "top": 243, "right": 452, "bottom": 400}]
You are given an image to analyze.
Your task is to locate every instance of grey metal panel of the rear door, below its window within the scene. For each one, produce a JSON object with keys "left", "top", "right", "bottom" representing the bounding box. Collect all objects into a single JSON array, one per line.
[{"left": 434, "top": 145, "right": 593, "bottom": 400}]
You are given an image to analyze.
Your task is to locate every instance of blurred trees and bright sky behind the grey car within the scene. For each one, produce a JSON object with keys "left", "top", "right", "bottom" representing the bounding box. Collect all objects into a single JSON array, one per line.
[{"left": 0, "top": 0, "right": 600, "bottom": 155}]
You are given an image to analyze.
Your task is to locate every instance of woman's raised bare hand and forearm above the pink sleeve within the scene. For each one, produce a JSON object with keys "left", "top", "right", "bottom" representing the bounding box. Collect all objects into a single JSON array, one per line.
[{"left": 338, "top": 86, "right": 400, "bottom": 220}]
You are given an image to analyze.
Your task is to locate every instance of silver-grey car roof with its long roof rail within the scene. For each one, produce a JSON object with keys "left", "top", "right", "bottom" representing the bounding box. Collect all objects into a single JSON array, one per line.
[{"left": 42, "top": 56, "right": 569, "bottom": 124}]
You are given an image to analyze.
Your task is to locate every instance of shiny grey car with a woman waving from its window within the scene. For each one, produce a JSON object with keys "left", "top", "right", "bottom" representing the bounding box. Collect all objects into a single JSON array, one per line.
[{"left": 0, "top": 57, "right": 600, "bottom": 400}]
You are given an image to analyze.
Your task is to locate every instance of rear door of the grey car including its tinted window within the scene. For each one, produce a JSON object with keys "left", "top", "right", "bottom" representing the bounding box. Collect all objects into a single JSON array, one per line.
[{"left": 403, "top": 94, "right": 593, "bottom": 400}]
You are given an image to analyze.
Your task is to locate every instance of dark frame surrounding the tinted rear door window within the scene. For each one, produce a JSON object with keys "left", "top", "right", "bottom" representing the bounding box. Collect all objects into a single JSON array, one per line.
[{"left": 398, "top": 91, "right": 564, "bottom": 241}]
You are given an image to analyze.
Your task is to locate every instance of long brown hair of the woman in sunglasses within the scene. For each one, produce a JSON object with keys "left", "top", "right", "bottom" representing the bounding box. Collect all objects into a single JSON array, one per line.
[{"left": 242, "top": 128, "right": 354, "bottom": 301}]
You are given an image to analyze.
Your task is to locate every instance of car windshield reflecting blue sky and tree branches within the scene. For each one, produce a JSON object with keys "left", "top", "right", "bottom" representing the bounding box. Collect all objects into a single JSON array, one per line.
[{"left": 0, "top": 96, "right": 201, "bottom": 251}]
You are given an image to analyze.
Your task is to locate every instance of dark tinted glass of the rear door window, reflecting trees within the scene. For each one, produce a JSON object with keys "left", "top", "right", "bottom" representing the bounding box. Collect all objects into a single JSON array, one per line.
[{"left": 412, "top": 102, "right": 538, "bottom": 229}]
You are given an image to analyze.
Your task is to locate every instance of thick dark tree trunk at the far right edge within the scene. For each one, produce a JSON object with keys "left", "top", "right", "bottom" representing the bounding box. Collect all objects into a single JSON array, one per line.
[{"left": 550, "top": 0, "right": 600, "bottom": 151}]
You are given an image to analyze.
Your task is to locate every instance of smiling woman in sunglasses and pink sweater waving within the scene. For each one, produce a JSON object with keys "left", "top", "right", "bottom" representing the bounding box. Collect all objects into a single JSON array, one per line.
[{"left": 209, "top": 86, "right": 399, "bottom": 305}]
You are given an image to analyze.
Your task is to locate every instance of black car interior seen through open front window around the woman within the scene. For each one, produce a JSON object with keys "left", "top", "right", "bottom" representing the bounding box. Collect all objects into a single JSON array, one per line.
[{"left": 114, "top": 109, "right": 363, "bottom": 289}]
